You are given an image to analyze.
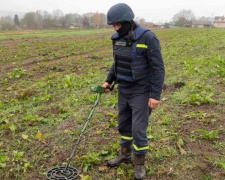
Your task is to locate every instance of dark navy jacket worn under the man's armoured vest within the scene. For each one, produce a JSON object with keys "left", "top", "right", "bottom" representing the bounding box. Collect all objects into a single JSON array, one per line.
[{"left": 106, "top": 23, "right": 165, "bottom": 100}]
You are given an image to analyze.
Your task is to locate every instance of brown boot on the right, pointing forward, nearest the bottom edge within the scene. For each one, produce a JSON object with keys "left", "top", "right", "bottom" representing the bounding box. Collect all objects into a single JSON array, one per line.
[{"left": 134, "top": 154, "right": 146, "bottom": 179}]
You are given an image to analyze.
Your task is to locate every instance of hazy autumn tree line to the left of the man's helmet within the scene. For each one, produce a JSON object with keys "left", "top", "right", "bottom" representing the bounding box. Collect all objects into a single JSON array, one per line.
[{"left": 0, "top": 9, "right": 106, "bottom": 31}]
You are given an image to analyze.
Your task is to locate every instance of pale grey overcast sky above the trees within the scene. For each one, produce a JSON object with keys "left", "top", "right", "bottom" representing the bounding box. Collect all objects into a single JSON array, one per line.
[{"left": 0, "top": 0, "right": 225, "bottom": 22}]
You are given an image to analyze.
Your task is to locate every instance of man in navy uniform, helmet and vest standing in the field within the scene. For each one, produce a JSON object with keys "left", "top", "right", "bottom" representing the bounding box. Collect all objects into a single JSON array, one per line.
[{"left": 102, "top": 3, "right": 165, "bottom": 179}]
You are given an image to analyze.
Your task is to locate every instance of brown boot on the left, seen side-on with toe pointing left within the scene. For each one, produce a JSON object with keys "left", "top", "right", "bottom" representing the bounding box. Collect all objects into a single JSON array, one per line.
[{"left": 108, "top": 147, "right": 131, "bottom": 167}]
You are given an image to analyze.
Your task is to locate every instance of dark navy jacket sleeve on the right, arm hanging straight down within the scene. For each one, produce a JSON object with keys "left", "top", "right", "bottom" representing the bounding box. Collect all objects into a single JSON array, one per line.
[{"left": 146, "top": 31, "right": 165, "bottom": 100}]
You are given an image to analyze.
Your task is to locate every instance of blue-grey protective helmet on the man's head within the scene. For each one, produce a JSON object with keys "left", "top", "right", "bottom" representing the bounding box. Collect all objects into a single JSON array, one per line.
[{"left": 107, "top": 3, "right": 134, "bottom": 25}]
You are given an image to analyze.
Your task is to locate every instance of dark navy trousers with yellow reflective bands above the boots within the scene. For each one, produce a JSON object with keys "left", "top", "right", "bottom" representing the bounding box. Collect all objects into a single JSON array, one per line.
[{"left": 118, "top": 92, "right": 151, "bottom": 155}]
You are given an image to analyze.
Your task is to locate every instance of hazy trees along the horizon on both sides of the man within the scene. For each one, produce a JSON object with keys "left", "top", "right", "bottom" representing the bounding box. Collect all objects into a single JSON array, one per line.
[{"left": 0, "top": 9, "right": 212, "bottom": 31}]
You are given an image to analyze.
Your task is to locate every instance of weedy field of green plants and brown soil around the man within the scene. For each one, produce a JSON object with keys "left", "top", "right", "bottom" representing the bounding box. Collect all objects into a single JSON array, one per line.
[{"left": 0, "top": 29, "right": 225, "bottom": 180}]
